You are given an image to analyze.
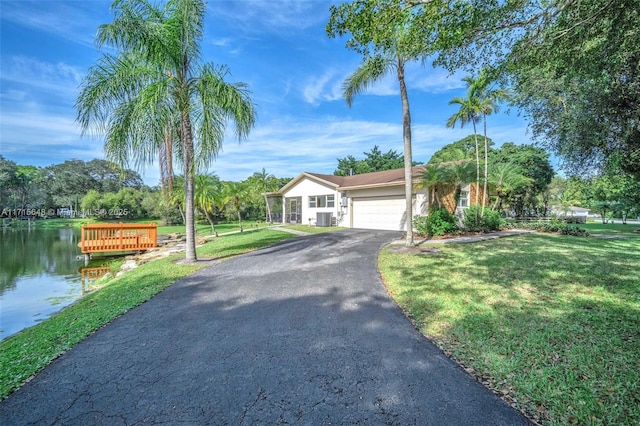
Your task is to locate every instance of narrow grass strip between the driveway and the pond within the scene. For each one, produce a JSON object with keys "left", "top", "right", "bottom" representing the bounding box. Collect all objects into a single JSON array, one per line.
[{"left": 0, "top": 229, "right": 293, "bottom": 400}]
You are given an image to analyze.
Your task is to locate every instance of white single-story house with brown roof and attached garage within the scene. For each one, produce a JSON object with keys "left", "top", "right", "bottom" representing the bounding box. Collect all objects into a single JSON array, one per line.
[{"left": 265, "top": 166, "right": 482, "bottom": 231}]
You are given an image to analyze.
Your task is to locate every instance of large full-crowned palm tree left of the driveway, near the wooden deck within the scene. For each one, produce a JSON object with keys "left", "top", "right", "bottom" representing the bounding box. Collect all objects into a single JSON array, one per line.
[{"left": 76, "top": 0, "right": 255, "bottom": 261}]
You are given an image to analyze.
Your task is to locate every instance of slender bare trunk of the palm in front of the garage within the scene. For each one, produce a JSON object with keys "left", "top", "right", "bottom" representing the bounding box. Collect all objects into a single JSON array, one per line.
[{"left": 398, "top": 58, "right": 413, "bottom": 247}]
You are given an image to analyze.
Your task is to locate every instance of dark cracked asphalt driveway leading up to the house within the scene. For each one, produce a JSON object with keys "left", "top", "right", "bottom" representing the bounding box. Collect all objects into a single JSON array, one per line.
[{"left": 0, "top": 230, "right": 527, "bottom": 426}]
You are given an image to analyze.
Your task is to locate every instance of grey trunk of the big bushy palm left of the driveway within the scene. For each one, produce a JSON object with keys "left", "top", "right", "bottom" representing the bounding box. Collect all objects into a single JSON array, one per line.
[{"left": 181, "top": 112, "right": 198, "bottom": 262}]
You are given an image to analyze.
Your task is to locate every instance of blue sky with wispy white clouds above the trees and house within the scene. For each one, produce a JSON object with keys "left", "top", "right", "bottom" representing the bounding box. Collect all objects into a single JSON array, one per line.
[{"left": 0, "top": 0, "right": 531, "bottom": 185}]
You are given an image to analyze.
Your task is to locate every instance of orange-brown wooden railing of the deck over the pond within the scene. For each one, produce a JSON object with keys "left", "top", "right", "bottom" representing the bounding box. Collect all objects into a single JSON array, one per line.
[{"left": 78, "top": 223, "right": 158, "bottom": 253}]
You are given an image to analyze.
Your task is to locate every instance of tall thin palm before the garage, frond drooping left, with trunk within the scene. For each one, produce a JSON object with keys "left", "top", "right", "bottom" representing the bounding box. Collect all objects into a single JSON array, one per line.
[{"left": 343, "top": 53, "right": 413, "bottom": 246}]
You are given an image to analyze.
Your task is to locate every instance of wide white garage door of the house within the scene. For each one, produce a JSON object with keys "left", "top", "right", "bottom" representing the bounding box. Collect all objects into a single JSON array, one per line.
[{"left": 353, "top": 197, "right": 407, "bottom": 231}]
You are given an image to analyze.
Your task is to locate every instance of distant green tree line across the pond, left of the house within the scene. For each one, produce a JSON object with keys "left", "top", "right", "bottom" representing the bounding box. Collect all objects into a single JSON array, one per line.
[{"left": 0, "top": 156, "right": 291, "bottom": 228}]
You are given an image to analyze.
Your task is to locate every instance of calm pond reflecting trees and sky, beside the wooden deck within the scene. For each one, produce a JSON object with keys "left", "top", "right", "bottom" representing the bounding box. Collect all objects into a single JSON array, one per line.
[{"left": 0, "top": 227, "right": 84, "bottom": 340}]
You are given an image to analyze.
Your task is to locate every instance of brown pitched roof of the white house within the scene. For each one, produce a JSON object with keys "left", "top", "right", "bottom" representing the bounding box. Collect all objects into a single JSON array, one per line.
[{"left": 278, "top": 166, "right": 425, "bottom": 194}]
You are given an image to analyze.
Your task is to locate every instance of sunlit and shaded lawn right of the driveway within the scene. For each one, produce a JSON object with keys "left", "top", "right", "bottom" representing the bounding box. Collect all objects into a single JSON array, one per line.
[{"left": 379, "top": 224, "right": 640, "bottom": 424}]
